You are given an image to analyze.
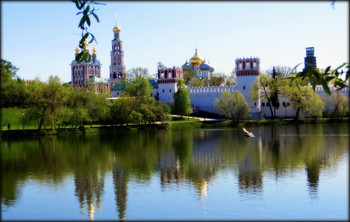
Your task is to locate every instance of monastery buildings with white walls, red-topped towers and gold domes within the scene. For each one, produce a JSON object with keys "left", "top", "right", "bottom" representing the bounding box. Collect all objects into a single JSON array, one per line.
[{"left": 71, "top": 22, "right": 348, "bottom": 119}]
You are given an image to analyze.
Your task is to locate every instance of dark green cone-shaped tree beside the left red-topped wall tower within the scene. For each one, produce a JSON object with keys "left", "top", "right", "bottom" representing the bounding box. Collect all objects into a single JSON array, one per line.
[{"left": 172, "top": 79, "right": 192, "bottom": 118}]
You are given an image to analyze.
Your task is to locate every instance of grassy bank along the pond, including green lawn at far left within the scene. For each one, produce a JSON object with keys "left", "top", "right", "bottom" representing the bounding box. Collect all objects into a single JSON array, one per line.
[{"left": 1, "top": 108, "right": 349, "bottom": 138}]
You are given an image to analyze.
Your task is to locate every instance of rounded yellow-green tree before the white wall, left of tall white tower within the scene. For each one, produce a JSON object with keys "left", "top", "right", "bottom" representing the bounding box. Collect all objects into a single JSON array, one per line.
[{"left": 215, "top": 91, "right": 250, "bottom": 122}]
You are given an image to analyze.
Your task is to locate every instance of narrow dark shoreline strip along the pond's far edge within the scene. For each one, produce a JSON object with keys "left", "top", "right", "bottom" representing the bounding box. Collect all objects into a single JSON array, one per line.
[{"left": 0, "top": 116, "right": 349, "bottom": 139}]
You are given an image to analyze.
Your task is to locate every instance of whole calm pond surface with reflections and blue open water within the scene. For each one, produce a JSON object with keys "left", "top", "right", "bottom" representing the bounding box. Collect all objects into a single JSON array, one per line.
[{"left": 1, "top": 124, "right": 349, "bottom": 220}]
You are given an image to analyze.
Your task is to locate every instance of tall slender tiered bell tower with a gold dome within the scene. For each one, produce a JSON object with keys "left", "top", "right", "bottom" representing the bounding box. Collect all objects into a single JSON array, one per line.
[{"left": 109, "top": 24, "right": 125, "bottom": 88}]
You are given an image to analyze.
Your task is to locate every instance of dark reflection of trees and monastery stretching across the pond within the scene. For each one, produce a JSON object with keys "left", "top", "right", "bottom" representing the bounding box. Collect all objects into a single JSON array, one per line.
[{"left": 1, "top": 124, "right": 349, "bottom": 220}]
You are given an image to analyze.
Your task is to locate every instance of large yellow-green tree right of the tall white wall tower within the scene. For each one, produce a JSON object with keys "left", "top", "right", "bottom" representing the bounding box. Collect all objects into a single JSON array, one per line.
[{"left": 281, "top": 79, "right": 324, "bottom": 120}]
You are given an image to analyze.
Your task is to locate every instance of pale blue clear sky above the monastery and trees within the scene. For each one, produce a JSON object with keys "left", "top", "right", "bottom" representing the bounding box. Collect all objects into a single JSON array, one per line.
[{"left": 1, "top": 1, "right": 349, "bottom": 82}]
